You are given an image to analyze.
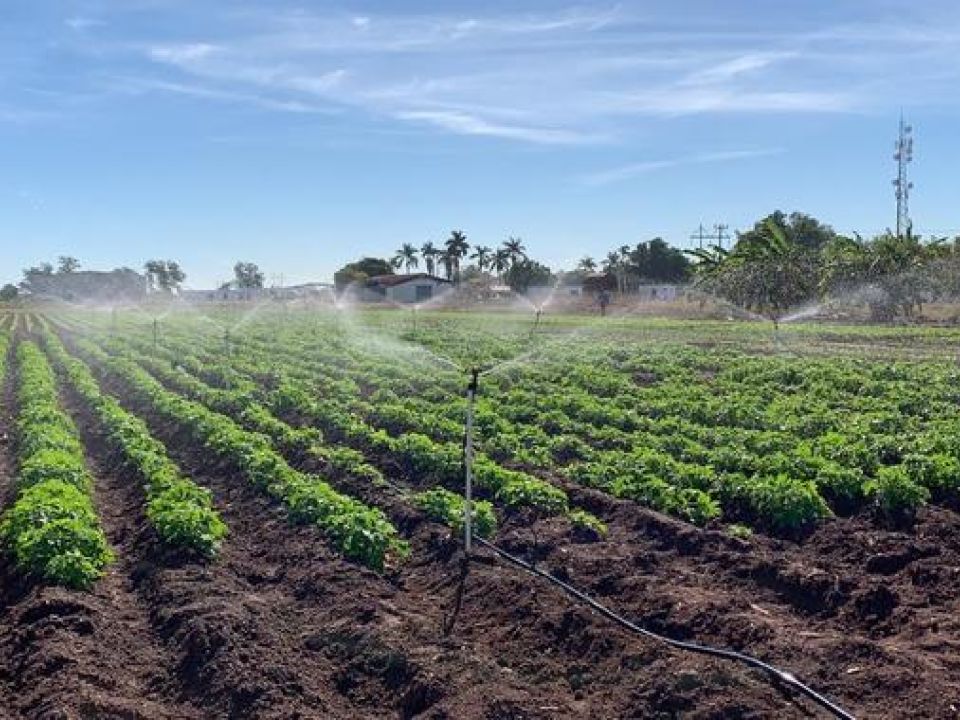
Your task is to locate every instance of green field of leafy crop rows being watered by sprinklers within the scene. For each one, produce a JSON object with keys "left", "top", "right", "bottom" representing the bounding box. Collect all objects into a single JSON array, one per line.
[{"left": 0, "top": 304, "right": 960, "bottom": 715}]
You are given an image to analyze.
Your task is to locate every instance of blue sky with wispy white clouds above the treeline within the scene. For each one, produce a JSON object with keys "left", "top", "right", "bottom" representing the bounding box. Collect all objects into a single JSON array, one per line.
[{"left": 0, "top": 0, "right": 960, "bottom": 287}]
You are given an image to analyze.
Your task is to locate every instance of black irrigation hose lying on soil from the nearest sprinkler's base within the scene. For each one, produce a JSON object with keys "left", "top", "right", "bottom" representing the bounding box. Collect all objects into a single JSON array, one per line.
[{"left": 473, "top": 536, "right": 855, "bottom": 720}]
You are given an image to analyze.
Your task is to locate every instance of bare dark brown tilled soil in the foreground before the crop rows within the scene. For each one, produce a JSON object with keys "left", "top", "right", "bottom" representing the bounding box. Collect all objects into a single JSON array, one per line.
[{"left": 0, "top": 334, "right": 960, "bottom": 720}]
